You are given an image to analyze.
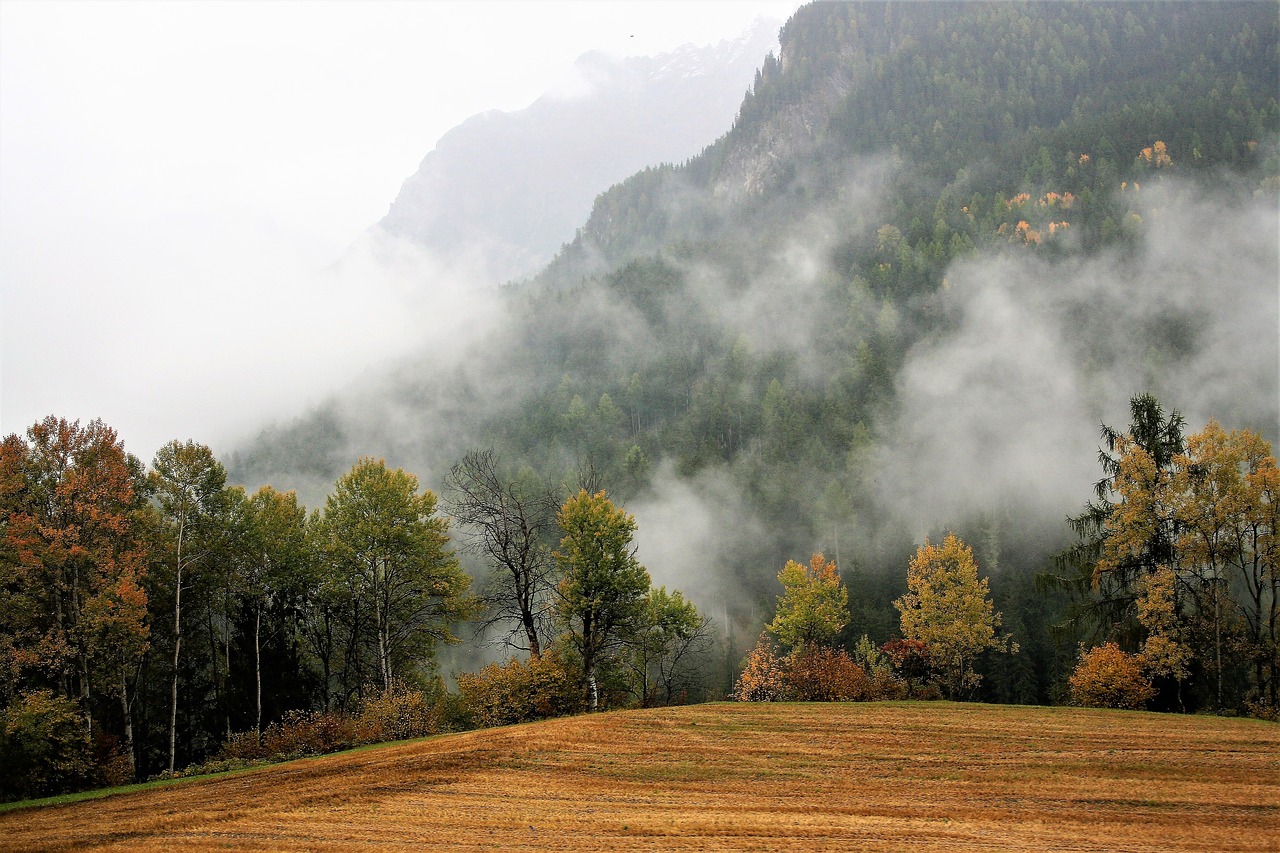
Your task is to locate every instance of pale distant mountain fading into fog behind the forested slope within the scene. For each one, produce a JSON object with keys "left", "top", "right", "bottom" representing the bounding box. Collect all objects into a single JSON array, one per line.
[{"left": 375, "top": 19, "right": 780, "bottom": 284}]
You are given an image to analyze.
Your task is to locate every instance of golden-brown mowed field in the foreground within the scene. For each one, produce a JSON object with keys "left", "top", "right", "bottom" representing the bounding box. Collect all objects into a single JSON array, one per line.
[{"left": 0, "top": 703, "right": 1280, "bottom": 853}]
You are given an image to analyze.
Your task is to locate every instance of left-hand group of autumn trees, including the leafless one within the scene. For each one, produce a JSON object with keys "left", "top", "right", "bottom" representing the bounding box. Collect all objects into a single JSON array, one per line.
[{"left": 0, "top": 416, "right": 712, "bottom": 795}]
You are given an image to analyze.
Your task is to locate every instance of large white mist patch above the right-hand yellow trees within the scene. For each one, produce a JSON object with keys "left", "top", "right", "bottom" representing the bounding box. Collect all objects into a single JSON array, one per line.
[{"left": 877, "top": 175, "right": 1280, "bottom": 529}]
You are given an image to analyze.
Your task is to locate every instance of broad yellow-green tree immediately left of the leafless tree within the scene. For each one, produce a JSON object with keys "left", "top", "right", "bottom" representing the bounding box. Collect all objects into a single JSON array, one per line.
[{"left": 323, "top": 457, "right": 476, "bottom": 692}]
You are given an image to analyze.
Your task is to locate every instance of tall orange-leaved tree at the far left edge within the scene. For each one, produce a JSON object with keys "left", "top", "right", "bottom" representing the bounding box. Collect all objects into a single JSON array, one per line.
[{"left": 0, "top": 418, "right": 148, "bottom": 774}]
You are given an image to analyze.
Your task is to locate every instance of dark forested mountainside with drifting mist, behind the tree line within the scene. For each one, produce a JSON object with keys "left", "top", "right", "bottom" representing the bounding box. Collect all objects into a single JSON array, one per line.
[{"left": 229, "top": 3, "right": 1280, "bottom": 701}]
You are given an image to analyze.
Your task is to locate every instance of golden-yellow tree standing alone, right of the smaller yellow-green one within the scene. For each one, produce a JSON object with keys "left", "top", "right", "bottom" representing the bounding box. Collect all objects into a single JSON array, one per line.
[{"left": 893, "top": 533, "right": 1018, "bottom": 698}]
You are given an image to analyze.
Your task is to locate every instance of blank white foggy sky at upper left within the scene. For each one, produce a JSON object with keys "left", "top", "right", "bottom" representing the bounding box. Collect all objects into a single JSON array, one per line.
[{"left": 0, "top": 0, "right": 800, "bottom": 460}]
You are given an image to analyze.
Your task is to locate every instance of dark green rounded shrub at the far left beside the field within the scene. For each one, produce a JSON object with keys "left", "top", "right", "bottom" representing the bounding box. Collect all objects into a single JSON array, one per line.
[{"left": 0, "top": 690, "right": 93, "bottom": 799}]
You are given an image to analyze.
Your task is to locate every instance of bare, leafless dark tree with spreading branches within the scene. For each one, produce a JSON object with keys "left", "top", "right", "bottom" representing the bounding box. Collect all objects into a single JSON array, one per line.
[{"left": 443, "top": 450, "right": 558, "bottom": 657}]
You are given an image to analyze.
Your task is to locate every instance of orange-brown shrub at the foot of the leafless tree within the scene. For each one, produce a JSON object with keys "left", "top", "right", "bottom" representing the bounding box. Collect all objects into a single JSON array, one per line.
[{"left": 458, "top": 651, "right": 581, "bottom": 726}]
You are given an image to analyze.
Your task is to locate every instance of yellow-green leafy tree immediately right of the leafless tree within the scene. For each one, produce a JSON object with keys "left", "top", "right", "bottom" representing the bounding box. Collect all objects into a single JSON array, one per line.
[{"left": 554, "top": 489, "right": 649, "bottom": 711}]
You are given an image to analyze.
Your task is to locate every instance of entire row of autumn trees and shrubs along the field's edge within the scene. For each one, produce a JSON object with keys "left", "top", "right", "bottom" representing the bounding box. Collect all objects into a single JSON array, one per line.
[{"left": 0, "top": 394, "right": 1280, "bottom": 795}]
